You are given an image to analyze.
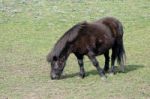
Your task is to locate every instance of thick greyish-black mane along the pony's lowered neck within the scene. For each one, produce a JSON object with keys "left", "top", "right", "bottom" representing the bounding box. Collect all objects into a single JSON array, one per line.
[{"left": 47, "top": 21, "right": 87, "bottom": 62}]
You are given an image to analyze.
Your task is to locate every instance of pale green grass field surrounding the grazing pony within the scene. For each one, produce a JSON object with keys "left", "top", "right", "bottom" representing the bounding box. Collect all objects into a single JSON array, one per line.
[{"left": 0, "top": 0, "right": 150, "bottom": 99}]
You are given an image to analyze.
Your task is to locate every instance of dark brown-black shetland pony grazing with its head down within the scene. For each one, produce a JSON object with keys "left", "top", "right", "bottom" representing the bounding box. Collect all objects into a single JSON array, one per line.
[{"left": 47, "top": 17, "right": 125, "bottom": 79}]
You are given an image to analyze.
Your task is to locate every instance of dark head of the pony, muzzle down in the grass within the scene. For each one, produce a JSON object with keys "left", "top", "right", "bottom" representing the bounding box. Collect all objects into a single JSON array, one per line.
[{"left": 47, "top": 53, "right": 66, "bottom": 79}]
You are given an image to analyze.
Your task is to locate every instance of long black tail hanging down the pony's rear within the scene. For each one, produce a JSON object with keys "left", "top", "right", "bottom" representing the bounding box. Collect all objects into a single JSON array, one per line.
[{"left": 114, "top": 23, "right": 126, "bottom": 72}]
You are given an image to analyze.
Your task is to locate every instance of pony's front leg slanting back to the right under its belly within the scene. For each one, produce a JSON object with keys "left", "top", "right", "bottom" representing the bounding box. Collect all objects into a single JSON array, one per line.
[{"left": 88, "top": 52, "right": 106, "bottom": 79}]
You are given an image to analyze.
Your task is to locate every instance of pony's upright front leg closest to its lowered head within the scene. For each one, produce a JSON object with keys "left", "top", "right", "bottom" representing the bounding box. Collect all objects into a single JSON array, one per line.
[{"left": 75, "top": 53, "right": 85, "bottom": 78}]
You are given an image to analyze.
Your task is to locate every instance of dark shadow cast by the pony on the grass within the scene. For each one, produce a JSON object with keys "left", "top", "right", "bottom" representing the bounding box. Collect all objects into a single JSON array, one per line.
[{"left": 61, "top": 65, "right": 144, "bottom": 79}]
